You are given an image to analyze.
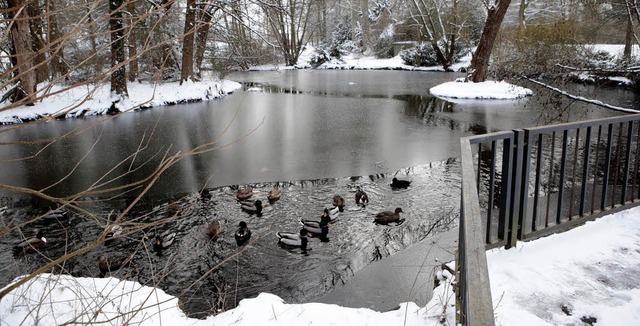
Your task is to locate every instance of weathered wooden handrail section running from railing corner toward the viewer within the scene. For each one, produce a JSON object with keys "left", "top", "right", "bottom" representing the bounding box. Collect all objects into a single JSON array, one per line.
[{"left": 458, "top": 138, "right": 495, "bottom": 326}]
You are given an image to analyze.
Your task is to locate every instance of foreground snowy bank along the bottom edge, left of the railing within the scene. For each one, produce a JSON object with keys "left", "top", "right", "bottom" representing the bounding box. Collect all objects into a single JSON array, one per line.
[{"left": 0, "top": 274, "right": 455, "bottom": 326}]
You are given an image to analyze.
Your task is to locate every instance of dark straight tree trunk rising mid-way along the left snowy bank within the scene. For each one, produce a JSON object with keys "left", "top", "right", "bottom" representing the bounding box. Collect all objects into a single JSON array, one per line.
[{"left": 109, "top": 0, "right": 128, "bottom": 96}]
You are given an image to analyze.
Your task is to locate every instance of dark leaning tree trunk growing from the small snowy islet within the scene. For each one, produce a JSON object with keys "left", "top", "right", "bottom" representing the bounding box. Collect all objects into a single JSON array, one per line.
[{"left": 471, "top": 0, "right": 511, "bottom": 83}]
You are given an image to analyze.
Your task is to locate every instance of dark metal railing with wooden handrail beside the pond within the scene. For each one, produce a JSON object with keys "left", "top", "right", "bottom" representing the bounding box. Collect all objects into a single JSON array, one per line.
[{"left": 457, "top": 115, "right": 640, "bottom": 325}]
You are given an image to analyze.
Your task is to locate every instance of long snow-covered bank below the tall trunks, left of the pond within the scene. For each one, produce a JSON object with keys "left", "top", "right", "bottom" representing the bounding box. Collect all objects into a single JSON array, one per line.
[{"left": 0, "top": 79, "right": 241, "bottom": 124}]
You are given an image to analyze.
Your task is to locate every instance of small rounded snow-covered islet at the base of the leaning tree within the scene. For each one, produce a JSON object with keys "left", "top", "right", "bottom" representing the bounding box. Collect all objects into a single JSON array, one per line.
[{"left": 429, "top": 80, "right": 533, "bottom": 100}]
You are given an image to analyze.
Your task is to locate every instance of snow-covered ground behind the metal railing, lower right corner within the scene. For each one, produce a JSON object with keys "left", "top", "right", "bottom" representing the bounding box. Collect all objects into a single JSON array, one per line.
[{"left": 487, "top": 207, "right": 640, "bottom": 326}]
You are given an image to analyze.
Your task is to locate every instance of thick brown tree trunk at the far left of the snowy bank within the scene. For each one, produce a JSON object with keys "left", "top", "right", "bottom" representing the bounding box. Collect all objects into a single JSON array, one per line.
[{"left": 7, "top": 0, "right": 36, "bottom": 105}]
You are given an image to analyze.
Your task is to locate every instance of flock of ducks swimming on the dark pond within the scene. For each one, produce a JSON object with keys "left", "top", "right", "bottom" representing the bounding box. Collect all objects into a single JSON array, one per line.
[{"left": 11, "top": 178, "right": 411, "bottom": 276}]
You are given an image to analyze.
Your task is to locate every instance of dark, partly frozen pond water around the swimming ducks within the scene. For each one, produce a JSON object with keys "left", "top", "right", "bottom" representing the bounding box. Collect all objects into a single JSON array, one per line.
[{"left": 0, "top": 70, "right": 636, "bottom": 316}]
